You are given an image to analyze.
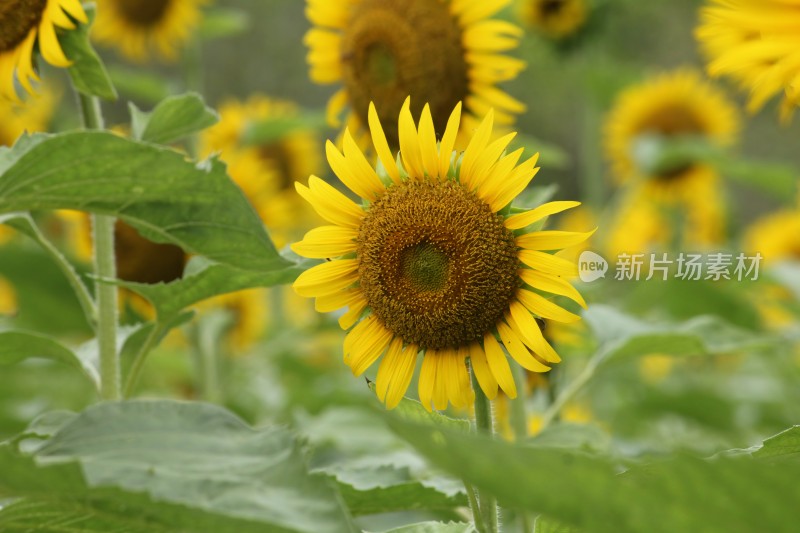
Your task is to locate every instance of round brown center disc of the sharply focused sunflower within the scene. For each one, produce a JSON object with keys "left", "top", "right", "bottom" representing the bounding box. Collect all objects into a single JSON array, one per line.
[{"left": 357, "top": 182, "right": 519, "bottom": 349}]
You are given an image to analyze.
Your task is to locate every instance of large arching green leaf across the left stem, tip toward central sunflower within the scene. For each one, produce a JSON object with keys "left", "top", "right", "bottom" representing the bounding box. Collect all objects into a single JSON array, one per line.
[{"left": 0, "top": 131, "right": 289, "bottom": 272}]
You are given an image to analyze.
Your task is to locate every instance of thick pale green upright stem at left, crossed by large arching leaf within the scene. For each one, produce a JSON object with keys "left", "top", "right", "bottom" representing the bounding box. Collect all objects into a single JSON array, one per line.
[{"left": 78, "top": 92, "right": 122, "bottom": 400}]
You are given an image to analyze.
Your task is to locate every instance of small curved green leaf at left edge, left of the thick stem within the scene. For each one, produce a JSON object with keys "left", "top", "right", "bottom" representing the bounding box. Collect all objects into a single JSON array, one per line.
[{"left": 0, "top": 331, "right": 100, "bottom": 386}]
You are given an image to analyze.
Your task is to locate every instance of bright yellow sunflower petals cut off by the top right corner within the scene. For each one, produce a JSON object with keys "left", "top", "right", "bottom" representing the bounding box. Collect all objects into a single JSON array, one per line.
[{"left": 696, "top": 0, "right": 800, "bottom": 120}]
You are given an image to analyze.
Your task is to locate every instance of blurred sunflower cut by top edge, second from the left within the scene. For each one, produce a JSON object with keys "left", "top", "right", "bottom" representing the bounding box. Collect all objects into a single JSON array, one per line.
[{"left": 92, "top": 0, "right": 209, "bottom": 62}]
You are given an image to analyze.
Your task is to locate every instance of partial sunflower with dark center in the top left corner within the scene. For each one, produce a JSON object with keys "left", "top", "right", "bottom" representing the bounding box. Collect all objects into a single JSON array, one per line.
[{"left": 0, "top": 0, "right": 88, "bottom": 101}]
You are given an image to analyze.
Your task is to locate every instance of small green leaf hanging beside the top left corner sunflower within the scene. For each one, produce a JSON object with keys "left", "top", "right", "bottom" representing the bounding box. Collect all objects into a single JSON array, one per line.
[{"left": 58, "top": 5, "right": 117, "bottom": 100}]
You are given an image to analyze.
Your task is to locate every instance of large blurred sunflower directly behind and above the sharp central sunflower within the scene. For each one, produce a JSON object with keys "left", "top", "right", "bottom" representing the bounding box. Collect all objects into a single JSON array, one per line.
[{"left": 305, "top": 0, "right": 525, "bottom": 149}]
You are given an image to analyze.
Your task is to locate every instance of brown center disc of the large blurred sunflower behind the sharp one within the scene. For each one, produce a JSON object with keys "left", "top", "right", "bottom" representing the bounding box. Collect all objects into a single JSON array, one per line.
[{"left": 341, "top": 0, "right": 468, "bottom": 147}]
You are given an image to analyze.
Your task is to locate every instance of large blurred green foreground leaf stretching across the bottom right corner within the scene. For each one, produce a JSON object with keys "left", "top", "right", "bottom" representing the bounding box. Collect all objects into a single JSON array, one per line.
[{"left": 387, "top": 415, "right": 800, "bottom": 533}]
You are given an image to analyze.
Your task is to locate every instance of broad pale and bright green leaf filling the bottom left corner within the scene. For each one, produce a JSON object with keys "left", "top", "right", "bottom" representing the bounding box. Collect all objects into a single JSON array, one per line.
[{"left": 0, "top": 401, "right": 355, "bottom": 533}]
